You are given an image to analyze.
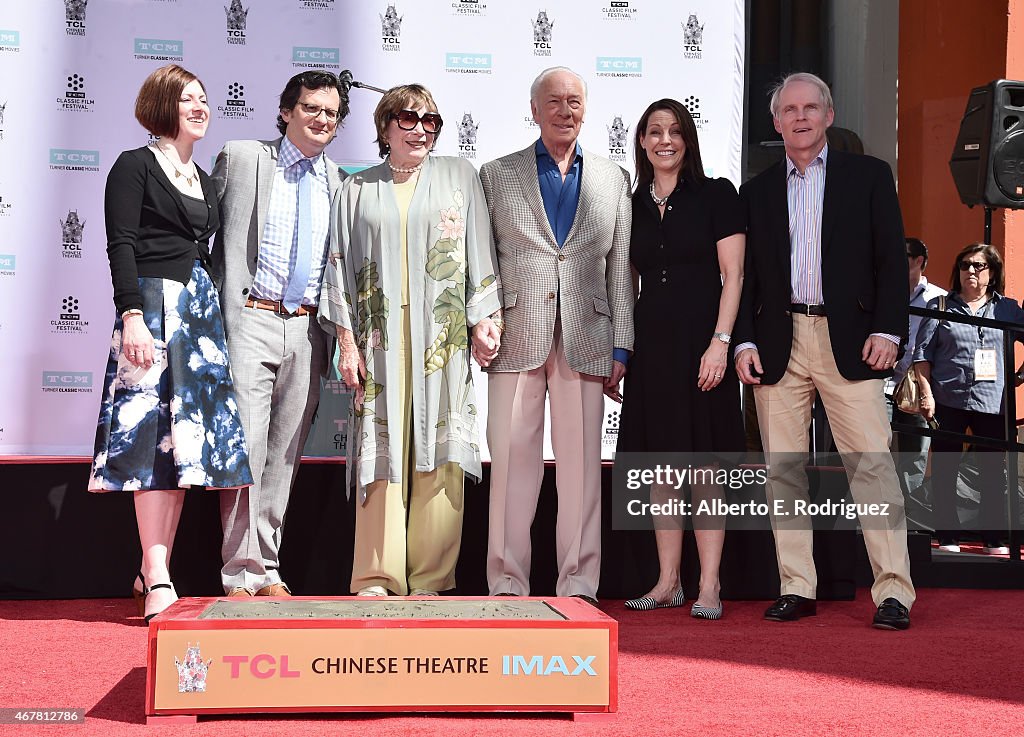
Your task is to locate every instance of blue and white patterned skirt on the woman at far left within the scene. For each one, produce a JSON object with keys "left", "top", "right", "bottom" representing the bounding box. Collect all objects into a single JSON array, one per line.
[{"left": 89, "top": 261, "right": 253, "bottom": 491}]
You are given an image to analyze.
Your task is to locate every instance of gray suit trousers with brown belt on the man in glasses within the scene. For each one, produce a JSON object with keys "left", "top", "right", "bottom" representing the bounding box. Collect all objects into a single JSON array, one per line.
[{"left": 220, "top": 307, "right": 329, "bottom": 592}]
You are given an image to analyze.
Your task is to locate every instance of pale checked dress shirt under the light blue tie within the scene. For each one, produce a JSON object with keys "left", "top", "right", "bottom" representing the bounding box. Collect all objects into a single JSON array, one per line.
[{"left": 251, "top": 136, "right": 331, "bottom": 305}]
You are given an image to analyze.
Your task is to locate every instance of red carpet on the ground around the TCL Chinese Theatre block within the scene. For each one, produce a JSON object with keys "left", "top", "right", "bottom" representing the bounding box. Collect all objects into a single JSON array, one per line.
[{"left": 0, "top": 590, "right": 1024, "bottom": 737}]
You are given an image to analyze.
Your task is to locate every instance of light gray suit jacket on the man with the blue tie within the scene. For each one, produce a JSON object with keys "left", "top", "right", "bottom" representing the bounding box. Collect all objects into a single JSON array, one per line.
[{"left": 210, "top": 138, "right": 341, "bottom": 365}]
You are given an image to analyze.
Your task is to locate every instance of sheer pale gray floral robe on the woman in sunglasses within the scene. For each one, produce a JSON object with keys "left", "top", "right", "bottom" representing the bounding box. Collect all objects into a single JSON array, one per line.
[{"left": 319, "top": 156, "right": 501, "bottom": 503}]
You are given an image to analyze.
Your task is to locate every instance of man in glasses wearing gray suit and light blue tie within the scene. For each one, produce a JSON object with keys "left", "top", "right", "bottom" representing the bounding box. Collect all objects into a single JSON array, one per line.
[{"left": 213, "top": 70, "right": 351, "bottom": 597}]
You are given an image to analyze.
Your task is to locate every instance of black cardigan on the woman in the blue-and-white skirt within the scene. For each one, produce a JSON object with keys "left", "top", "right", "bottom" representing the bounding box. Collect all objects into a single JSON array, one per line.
[{"left": 103, "top": 146, "right": 220, "bottom": 314}]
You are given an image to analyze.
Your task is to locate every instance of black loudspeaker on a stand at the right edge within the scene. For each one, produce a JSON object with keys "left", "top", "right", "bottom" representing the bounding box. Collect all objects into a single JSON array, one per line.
[{"left": 949, "top": 80, "right": 1024, "bottom": 210}]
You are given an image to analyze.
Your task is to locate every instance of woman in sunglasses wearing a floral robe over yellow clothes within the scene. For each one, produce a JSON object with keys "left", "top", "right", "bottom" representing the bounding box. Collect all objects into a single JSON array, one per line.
[{"left": 321, "top": 84, "right": 501, "bottom": 596}]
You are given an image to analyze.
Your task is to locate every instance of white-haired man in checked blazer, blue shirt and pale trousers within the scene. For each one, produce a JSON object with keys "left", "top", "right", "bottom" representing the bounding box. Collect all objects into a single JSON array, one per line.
[{"left": 480, "top": 67, "right": 633, "bottom": 603}]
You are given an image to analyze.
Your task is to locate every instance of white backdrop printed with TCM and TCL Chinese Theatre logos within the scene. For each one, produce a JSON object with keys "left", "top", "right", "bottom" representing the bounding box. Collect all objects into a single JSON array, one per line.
[{"left": 0, "top": 0, "right": 744, "bottom": 458}]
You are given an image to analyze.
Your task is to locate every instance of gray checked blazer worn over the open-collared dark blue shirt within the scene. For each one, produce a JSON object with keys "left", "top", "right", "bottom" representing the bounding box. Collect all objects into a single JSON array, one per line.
[{"left": 480, "top": 143, "right": 633, "bottom": 377}]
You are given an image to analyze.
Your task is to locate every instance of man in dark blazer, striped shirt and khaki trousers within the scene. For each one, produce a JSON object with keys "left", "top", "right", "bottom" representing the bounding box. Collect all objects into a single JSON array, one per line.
[{"left": 733, "top": 73, "right": 914, "bottom": 630}]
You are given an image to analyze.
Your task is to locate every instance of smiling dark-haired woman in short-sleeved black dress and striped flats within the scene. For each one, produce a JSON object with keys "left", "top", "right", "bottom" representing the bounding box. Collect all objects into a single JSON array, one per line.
[{"left": 618, "top": 99, "right": 745, "bottom": 619}]
